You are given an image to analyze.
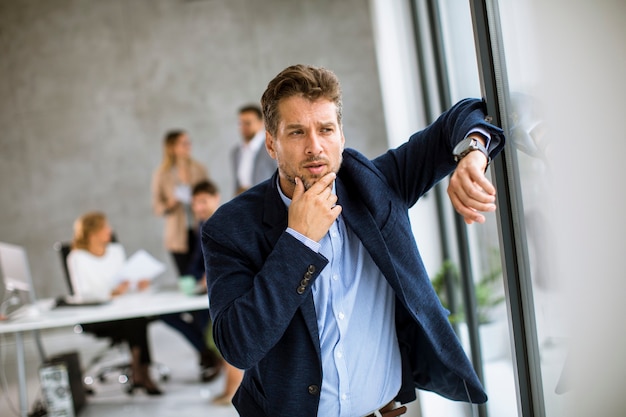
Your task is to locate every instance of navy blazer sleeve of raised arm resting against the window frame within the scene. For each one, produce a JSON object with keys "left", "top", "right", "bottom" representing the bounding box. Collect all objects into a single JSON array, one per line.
[{"left": 373, "top": 99, "right": 504, "bottom": 207}]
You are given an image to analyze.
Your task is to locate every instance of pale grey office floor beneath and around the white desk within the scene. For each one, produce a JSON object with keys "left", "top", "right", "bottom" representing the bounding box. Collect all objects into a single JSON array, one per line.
[{"left": 0, "top": 322, "right": 237, "bottom": 417}]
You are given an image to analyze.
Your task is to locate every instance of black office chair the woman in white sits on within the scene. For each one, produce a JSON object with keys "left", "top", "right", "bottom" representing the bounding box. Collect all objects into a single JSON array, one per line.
[{"left": 53, "top": 239, "right": 170, "bottom": 394}]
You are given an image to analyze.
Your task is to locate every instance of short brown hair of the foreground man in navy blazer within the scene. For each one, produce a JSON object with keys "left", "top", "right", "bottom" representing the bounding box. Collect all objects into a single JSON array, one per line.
[{"left": 261, "top": 64, "right": 343, "bottom": 136}]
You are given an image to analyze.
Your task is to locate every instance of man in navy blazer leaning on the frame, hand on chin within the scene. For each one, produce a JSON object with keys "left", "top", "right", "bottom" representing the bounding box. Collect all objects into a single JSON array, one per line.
[{"left": 202, "top": 65, "right": 504, "bottom": 417}]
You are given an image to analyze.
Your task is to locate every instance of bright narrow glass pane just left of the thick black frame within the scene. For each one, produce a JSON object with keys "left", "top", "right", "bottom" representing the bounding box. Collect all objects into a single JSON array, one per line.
[{"left": 424, "top": 0, "right": 518, "bottom": 417}]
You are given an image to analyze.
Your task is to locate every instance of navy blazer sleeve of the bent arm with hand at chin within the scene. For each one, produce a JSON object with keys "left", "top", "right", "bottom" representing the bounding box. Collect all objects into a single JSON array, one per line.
[{"left": 202, "top": 216, "right": 328, "bottom": 369}]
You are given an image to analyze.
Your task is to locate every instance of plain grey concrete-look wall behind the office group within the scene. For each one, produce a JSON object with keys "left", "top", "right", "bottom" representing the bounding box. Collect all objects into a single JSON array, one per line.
[{"left": 0, "top": 0, "right": 386, "bottom": 297}]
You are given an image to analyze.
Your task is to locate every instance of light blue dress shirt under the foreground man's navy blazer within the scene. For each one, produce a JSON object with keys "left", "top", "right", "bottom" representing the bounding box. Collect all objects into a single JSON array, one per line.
[{"left": 278, "top": 184, "right": 402, "bottom": 417}]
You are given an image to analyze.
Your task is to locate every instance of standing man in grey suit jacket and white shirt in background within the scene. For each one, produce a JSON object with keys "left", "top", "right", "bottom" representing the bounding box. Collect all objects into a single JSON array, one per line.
[{"left": 232, "top": 104, "right": 276, "bottom": 195}]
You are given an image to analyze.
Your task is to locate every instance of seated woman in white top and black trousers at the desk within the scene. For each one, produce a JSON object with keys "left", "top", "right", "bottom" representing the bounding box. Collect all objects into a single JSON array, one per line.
[{"left": 67, "top": 212, "right": 162, "bottom": 395}]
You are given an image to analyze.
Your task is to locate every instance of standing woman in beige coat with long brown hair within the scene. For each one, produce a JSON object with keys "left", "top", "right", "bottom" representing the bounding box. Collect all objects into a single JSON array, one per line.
[{"left": 152, "top": 130, "right": 208, "bottom": 275}]
